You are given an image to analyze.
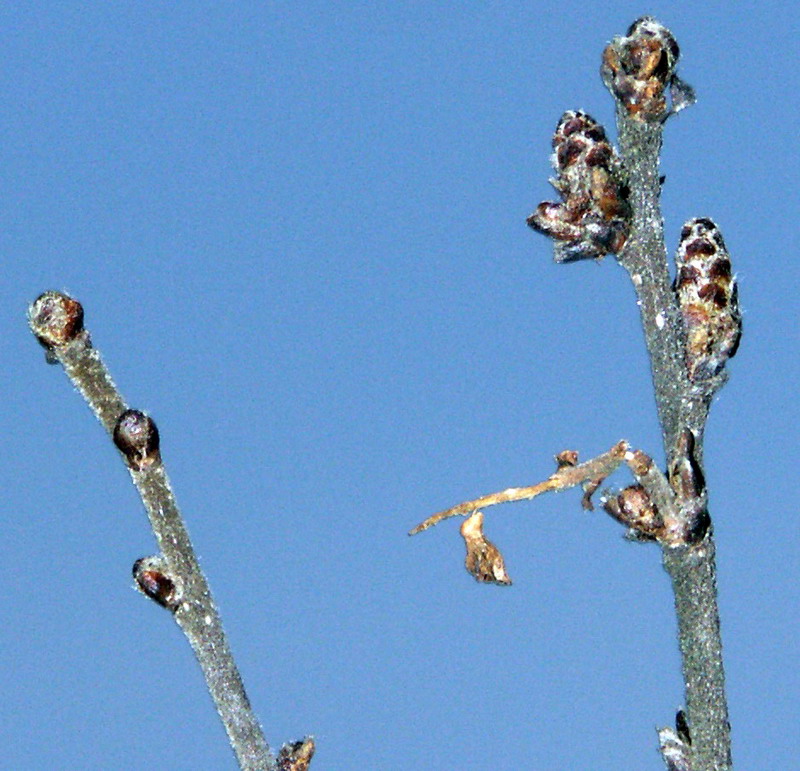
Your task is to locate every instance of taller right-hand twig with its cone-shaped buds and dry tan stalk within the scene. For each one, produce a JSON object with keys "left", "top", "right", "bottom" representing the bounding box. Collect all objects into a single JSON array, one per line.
[{"left": 411, "top": 17, "right": 741, "bottom": 771}]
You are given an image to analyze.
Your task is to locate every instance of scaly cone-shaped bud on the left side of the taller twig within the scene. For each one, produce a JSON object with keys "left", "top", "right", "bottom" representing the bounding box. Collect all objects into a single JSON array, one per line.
[{"left": 528, "top": 110, "right": 630, "bottom": 262}]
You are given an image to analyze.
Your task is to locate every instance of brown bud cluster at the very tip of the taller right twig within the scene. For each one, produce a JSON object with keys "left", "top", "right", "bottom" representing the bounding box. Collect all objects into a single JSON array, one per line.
[{"left": 600, "top": 16, "right": 694, "bottom": 122}]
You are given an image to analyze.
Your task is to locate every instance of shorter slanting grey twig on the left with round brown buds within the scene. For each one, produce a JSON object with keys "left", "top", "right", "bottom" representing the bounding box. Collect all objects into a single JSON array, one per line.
[{"left": 29, "top": 292, "right": 280, "bottom": 771}]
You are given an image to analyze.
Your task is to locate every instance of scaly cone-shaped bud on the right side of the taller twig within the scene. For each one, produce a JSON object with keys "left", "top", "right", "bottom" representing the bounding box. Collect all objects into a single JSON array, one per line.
[{"left": 675, "top": 217, "right": 742, "bottom": 383}]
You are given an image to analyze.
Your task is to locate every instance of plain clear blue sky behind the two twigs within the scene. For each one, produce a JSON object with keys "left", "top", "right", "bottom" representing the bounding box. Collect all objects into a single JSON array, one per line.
[{"left": 0, "top": 2, "right": 800, "bottom": 771}]
